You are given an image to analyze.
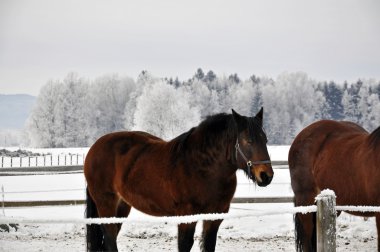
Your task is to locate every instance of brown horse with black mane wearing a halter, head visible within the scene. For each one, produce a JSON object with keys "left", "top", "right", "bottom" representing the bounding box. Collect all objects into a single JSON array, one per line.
[{"left": 84, "top": 109, "right": 273, "bottom": 251}]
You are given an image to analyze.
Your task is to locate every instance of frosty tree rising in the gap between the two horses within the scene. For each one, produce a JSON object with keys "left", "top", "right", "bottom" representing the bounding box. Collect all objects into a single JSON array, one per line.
[{"left": 262, "top": 72, "right": 325, "bottom": 144}]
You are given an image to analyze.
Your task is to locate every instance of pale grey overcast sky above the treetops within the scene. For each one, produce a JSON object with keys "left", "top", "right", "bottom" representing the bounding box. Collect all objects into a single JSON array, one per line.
[{"left": 0, "top": 0, "right": 380, "bottom": 95}]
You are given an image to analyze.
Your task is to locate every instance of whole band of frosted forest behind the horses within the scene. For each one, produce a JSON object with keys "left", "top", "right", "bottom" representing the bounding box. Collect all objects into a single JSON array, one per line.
[{"left": 23, "top": 68, "right": 380, "bottom": 147}]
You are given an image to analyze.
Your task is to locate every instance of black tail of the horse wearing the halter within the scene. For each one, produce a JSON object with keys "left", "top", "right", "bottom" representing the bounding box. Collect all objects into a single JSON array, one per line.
[{"left": 86, "top": 188, "right": 104, "bottom": 251}]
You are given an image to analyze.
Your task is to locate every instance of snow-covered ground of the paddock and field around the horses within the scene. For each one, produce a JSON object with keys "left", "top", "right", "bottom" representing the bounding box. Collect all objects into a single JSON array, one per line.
[{"left": 0, "top": 146, "right": 377, "bottom": 251}]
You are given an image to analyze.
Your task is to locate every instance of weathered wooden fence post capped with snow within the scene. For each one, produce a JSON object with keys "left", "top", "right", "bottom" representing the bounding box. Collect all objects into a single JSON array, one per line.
[{"left": 315, "top": 189, "right": 336, "bottom": 252}]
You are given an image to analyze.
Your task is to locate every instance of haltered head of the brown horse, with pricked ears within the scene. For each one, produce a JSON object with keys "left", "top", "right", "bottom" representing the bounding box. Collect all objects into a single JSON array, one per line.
[{"left": 232, "top": 108, "right": 273, "bottom": 186}]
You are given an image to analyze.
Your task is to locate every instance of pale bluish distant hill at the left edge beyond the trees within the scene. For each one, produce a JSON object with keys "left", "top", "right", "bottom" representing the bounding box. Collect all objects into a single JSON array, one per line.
[{"left": 0, "top": 94, "right": 36, "bottom": 130}]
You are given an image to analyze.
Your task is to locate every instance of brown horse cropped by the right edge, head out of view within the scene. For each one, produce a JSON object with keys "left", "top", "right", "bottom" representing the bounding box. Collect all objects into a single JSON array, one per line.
[{"left": 289, "top": 120, "right": 380, "bottom": 251}]
